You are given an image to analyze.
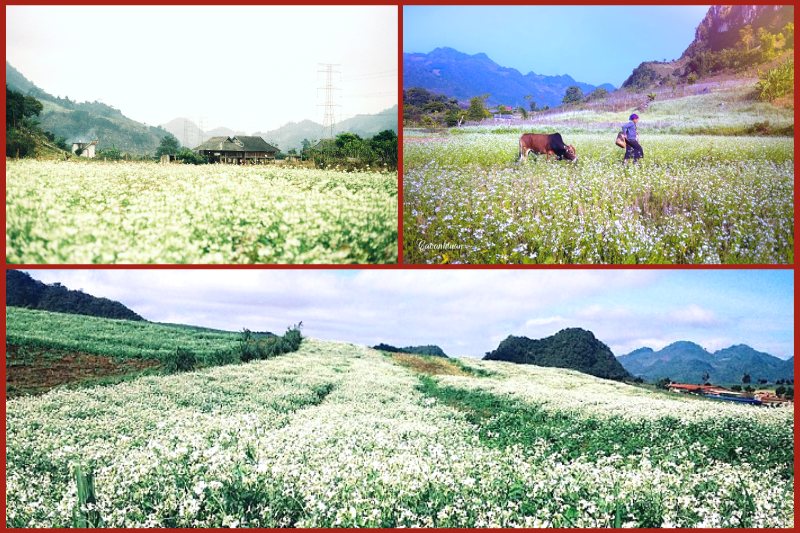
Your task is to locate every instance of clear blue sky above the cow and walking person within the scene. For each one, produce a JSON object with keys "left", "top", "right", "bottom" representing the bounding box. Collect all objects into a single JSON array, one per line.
[{"left": 403, "top": 6, "right": 709, "bottom": 87}]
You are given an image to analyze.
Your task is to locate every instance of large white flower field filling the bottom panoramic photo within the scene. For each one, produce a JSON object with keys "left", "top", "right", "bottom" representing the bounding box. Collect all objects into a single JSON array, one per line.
[{"left": 6, "top": 339, "right": 794, "bottom": 527}]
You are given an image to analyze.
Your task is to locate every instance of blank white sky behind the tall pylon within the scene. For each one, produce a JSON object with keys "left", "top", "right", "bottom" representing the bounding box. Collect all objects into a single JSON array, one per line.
[{"left": 6, "top": 6, "right": 398, "bottom": 133}]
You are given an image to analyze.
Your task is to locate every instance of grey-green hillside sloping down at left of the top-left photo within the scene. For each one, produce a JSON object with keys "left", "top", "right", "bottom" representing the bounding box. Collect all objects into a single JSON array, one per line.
[{"left": 6, "top": 61, "right": 172, "bottom": 155}]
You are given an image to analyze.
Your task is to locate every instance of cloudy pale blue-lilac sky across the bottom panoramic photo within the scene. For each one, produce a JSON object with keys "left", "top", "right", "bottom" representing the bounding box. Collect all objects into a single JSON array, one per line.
[{"left": 21, "top": 270, "right": 794, "bottom": 358}]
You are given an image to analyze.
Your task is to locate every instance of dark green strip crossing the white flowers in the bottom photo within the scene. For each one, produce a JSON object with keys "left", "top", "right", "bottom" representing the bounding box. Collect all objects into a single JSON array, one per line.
[{"left": 418, "top": 375, "right": 794, "bottom": 479}]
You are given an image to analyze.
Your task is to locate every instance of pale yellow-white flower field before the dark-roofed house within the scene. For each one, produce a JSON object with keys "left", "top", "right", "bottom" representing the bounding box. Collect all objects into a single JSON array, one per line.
[{"left": 6, "top": 160, "right": 397, "bottom": 264}]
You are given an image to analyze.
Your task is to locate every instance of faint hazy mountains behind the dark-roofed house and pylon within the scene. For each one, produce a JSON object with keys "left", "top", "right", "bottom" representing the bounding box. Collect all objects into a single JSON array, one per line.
[{"left": 161, "top": 106, "right": 397, "bottom": 152}]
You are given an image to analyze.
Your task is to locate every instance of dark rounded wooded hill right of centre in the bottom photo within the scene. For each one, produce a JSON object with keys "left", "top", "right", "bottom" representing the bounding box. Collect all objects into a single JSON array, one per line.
[{"left": 484, "top": 328, "right": 630, "bottom": 380}]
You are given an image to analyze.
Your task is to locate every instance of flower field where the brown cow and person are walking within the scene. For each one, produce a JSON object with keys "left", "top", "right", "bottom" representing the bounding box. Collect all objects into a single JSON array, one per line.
[{"left": 403, "top": 132, "right": 794, "bottom": 264}]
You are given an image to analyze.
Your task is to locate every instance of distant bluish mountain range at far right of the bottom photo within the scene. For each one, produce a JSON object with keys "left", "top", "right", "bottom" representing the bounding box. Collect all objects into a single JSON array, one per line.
[{"left": 617, "top": 341, "right": 794, "bottom": 384}]
